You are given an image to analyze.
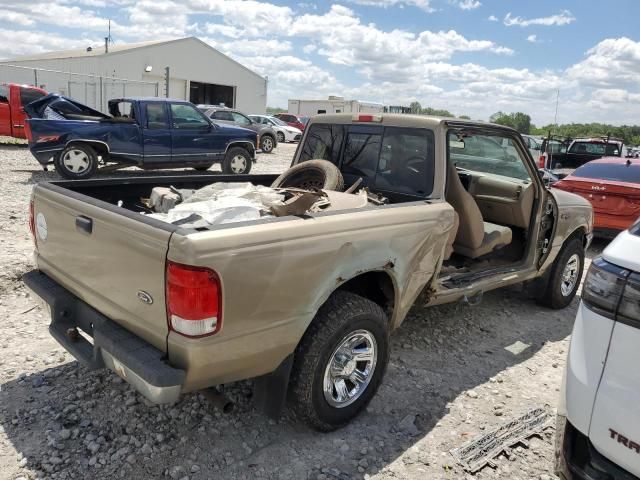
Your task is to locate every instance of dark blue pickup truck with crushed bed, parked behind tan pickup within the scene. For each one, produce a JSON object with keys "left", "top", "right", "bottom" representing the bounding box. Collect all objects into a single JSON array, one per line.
[{"left": 25, "top": 94, "right": 257, "bottom": 179}]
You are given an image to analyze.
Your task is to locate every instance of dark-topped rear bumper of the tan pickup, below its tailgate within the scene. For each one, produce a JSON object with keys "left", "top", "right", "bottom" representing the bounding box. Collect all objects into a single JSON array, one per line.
[{"left": 23, "top": 270, "right": 186, "bottom": 403}]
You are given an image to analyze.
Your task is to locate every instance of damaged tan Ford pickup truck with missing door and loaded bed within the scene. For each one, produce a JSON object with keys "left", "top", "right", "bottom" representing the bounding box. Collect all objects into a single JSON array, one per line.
[{"left": 24, "top": 114, "right": 593, "bottom": 430}]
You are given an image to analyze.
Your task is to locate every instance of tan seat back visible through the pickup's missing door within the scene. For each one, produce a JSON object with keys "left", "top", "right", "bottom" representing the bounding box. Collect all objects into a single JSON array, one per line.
[{"left": 445, "top": 163, "right": 484, "bottom": 250}]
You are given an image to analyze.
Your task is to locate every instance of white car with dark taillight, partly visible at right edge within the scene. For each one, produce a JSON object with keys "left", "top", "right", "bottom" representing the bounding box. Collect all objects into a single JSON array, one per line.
[{"left": 556, "top": 220, "right": 640, "bottom": 480}]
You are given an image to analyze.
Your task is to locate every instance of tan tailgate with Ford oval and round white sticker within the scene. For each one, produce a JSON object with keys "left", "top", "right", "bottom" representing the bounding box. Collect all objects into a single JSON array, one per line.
[{"left": 33, "top": 184, "right": 172, "bottom": 352}]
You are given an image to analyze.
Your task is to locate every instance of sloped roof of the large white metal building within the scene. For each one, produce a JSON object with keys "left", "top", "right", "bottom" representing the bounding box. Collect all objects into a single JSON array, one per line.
[{"left": 0, "top": 37, "right": 264, "bottom": 80}]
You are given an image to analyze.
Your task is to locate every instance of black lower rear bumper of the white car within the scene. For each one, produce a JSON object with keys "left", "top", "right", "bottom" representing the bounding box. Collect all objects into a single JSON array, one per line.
[{"left": 555, "top": 415, "right": 638, "bottom": 480}]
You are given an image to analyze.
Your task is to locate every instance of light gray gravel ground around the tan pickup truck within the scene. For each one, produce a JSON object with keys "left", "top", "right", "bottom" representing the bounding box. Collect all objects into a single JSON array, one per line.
[{"left": 0, "top": 145, "right": 604, "bottom": 480}]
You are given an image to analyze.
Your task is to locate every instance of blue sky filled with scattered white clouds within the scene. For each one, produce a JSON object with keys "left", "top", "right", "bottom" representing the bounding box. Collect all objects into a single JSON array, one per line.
[{"left": 0, "top": 0, "right": 640, "bottom": 124}]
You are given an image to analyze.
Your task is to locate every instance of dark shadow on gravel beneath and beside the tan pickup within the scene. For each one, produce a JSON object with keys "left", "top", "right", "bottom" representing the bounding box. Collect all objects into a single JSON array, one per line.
[{"left": 0, "top": 245, "right": 601, "bottom": 479}]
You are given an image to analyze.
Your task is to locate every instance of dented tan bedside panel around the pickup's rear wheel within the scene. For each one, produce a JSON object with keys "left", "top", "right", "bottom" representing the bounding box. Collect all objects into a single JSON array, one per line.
[{"left": 168, "top": 203, "right": 453, "bottom": 390}]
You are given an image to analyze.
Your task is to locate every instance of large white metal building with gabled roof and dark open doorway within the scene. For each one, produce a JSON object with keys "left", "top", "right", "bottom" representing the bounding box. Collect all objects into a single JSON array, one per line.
[{"left": 0, "top": 37, "right": 267, "bottom": 114}]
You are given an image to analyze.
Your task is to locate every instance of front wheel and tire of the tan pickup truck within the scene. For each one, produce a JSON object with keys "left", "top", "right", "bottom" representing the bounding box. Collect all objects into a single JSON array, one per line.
[{"left": 538, "top": 238, "right": 584, "bottom": 309}]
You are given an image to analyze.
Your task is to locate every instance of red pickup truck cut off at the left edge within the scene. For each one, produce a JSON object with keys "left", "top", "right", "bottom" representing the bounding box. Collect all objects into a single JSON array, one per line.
[{"left": 0, "top": 83, "right": 47, "bottom": 138}]
